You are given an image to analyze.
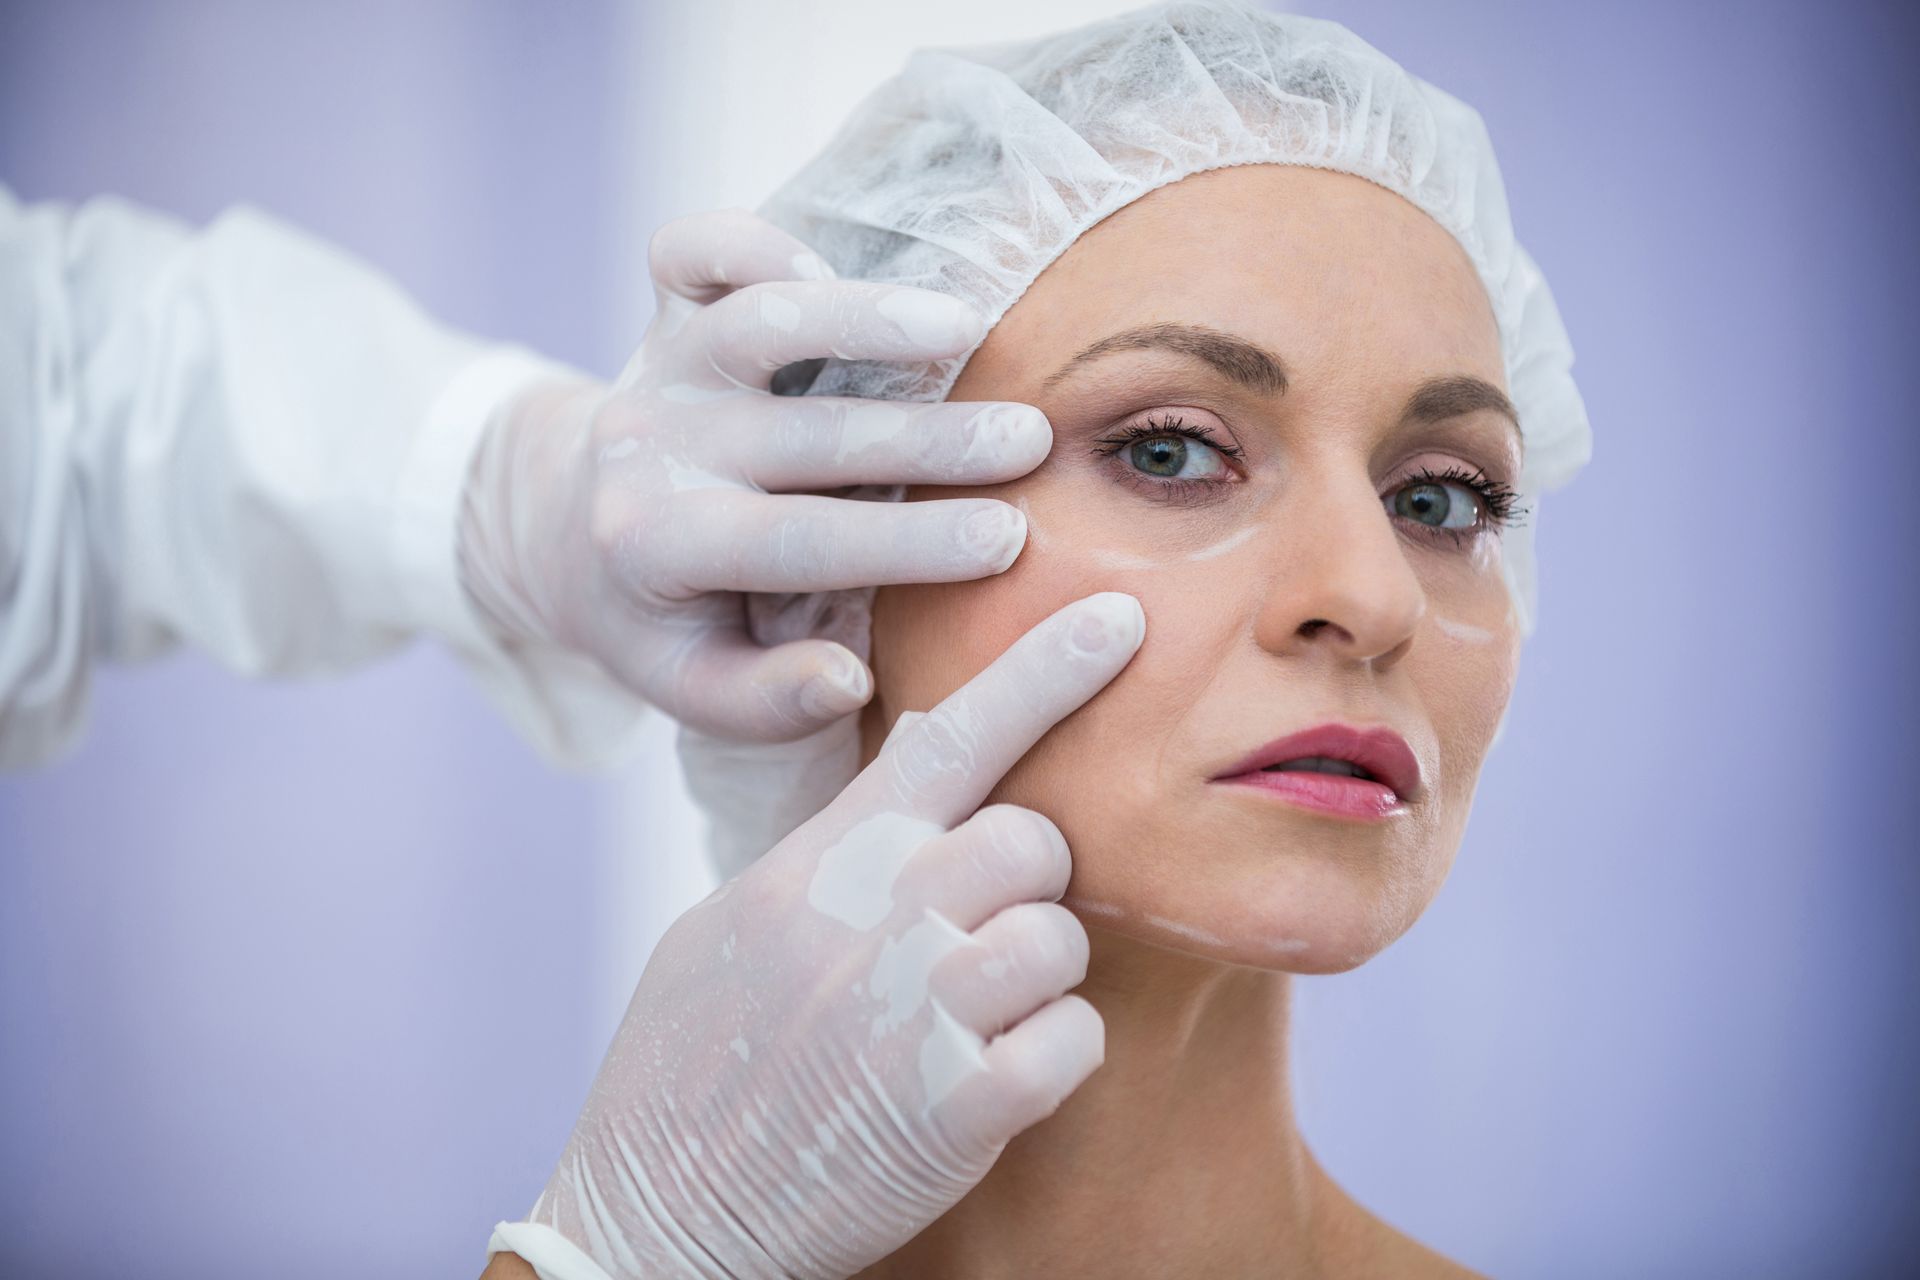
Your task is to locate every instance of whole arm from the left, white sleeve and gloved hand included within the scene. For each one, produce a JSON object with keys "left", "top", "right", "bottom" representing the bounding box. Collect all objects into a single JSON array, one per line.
[{"left": 0, "top": 190, "right": 1052, "bottom": 766}]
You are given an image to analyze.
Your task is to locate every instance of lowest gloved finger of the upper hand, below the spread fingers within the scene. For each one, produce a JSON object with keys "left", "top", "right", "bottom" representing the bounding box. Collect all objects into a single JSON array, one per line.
[{"left": 609, "top": 629, "right": 874, "bottom": 743}]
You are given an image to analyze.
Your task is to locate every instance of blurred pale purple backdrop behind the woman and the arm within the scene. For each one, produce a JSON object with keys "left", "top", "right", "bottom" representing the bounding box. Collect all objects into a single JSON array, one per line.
[{"left": 0, "top": 0, "right": 1920, "bottom": 1278}]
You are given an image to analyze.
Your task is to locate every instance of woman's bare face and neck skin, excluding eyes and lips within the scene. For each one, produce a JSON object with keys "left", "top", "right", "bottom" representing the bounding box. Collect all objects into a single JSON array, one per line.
[{"left": 862, "top": 165, "right": 1519, "bottom": 1280}]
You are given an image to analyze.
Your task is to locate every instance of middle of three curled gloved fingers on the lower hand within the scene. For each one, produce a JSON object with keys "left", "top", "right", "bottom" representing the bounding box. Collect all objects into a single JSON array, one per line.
[{"left": 927, "top": 902, "right": 1087, "bottom": 1036}]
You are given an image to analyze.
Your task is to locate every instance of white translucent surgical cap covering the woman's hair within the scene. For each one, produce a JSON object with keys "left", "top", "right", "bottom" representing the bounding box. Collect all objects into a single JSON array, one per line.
[{"left": 695, "top": 2, "right": 1590, "bottom": 865}]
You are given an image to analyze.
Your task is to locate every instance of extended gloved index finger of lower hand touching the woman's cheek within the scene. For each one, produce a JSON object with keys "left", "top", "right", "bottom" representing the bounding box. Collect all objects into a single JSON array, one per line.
[{"left": 864, "top": 594, "right": 1146, "bottom": 827}]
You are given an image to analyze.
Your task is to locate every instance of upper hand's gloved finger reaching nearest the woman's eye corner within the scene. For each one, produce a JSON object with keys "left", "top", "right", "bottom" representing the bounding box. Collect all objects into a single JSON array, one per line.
[{"left": 721, "top": 395, "right": 1054, "bottom": 491}]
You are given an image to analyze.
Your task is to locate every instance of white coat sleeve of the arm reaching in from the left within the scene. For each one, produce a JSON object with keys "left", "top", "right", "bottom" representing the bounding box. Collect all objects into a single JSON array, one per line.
[{"left": 0, "top": 188, "right": 641, "bottom": 766}]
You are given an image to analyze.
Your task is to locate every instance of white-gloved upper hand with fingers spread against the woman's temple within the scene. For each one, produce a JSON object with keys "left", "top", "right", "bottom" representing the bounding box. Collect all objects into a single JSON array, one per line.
[{"left": 459, "top": 211, "right": 1052, "bottom": 741}]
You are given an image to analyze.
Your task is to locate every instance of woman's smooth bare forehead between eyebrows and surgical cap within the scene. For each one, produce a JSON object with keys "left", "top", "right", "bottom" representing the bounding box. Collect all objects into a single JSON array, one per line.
[{"left": 975, "top": 165, "right": 1505, "bottom": 395}]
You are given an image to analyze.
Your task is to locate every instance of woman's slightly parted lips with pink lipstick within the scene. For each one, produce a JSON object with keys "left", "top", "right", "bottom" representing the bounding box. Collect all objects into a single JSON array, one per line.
[{"left": 1212, "top": 723, "right": 1421, "bottom": 821}]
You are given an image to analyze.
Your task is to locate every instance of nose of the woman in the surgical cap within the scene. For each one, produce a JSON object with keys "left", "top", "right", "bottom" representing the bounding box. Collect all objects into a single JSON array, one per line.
[{"left": 1254, "top": 475, "right": 1427, "bottom": 666}]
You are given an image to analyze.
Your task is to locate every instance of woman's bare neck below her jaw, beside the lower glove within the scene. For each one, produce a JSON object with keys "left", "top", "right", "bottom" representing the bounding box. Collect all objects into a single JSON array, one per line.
[{"left": 862, "top": 929, "right": 1363, "bottom": 1280}]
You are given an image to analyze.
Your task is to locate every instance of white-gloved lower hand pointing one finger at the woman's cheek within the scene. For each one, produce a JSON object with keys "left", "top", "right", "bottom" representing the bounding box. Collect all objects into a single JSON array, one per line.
[{"left": 493, "top": 593, "right": 1146, "bottom": 1280}]
